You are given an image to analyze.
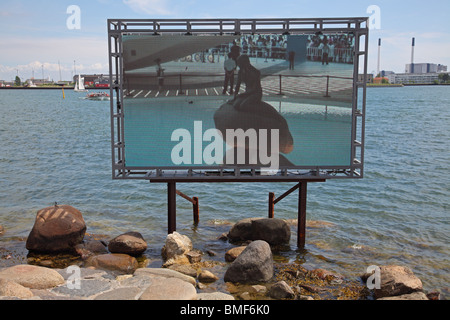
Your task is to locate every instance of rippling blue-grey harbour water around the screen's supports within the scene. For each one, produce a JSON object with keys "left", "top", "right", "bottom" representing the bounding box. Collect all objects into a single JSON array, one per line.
[{"left": 0, "top": 86, "right": 450, "bottom": 296}]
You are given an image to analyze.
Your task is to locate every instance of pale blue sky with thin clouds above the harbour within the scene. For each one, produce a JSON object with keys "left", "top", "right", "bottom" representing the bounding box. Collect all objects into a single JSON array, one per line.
[{"left": 0, "top": 0, "right": 450, "bottom": 81}]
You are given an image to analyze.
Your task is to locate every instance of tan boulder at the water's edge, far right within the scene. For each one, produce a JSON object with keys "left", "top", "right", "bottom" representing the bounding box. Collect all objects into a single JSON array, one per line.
[{"left": 362, "top": 265, "right": 422, "bottom": 299}]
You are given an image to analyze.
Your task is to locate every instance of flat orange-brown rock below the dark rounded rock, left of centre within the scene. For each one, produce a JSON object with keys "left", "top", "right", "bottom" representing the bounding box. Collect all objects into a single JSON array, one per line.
[{"left": 87, "top": 253, "right": 138, "bottom": 274}]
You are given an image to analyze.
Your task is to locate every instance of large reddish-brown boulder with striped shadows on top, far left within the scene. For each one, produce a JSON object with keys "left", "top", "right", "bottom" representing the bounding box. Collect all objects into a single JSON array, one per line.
[{"left": 26, "top": 205, "right": 86, "bottom": 253}]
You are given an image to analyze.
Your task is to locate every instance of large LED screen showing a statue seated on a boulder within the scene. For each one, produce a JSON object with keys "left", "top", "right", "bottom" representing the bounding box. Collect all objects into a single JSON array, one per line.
[{"left": 123, "top": 33, "right": 355, "bottom": 171}]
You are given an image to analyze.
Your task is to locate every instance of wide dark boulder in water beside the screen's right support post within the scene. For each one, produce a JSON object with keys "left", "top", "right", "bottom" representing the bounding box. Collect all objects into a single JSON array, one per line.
[{"left": 228, "top": 218, "right": 291, "bottom": 245}]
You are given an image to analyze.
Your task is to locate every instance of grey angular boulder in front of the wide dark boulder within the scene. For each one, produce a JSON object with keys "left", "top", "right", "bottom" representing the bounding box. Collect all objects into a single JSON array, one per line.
[{"left": 224, "top": 240, "right": 274, "bottom": 283}]
